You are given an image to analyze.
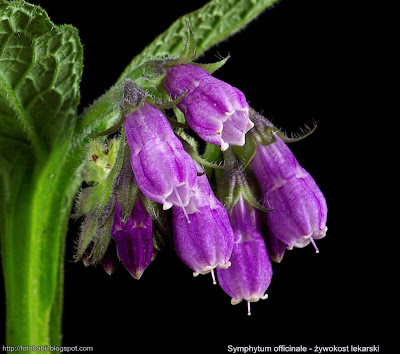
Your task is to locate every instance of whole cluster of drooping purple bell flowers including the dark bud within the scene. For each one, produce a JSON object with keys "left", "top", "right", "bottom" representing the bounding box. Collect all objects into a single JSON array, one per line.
[{"left": 79, "top": 64, "right": 327, "bottom": 314}]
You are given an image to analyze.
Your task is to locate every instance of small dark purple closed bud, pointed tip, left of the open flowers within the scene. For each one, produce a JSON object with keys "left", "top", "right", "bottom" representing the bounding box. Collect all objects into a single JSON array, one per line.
[{"left": 111, "top": 197, "right": 153, "bottom": 279}]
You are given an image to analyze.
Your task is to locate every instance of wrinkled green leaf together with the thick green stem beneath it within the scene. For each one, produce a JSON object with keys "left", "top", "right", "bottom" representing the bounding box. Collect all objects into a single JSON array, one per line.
[{"left": 0, "top": 0, "right": 82, "bottom": 345}]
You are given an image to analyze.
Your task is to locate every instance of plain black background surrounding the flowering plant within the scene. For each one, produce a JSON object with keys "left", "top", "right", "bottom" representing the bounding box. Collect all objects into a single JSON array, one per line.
[{"left": 0, "top": 0, "right": 398, "bottom": 353}]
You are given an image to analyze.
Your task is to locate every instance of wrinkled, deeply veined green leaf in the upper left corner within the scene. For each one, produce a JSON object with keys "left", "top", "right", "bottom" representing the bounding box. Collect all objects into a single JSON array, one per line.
[{"left": 0, "top": 1, "right": 82, "bottom": 157}]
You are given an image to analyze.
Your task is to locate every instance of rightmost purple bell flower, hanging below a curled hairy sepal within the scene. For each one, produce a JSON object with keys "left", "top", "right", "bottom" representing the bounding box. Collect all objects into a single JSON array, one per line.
[{"left": 251, "top": 135, "right": 328, "bottom": 252}]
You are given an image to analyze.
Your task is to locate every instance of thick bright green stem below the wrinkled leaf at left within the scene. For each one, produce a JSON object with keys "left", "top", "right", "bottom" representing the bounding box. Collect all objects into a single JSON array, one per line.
[{"left": 1, "top": 143, "right": 79, "bottom": 346}]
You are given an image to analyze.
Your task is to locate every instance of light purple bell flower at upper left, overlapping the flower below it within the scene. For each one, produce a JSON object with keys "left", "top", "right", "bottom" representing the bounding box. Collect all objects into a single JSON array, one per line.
[{"left": 125, "top": 102, "right": 197, "bottom": 210}]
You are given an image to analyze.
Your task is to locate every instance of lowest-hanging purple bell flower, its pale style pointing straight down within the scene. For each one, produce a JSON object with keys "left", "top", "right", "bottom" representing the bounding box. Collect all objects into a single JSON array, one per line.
[{"left": 217, "top": 195, "right": 272, "bottom": 315}]
